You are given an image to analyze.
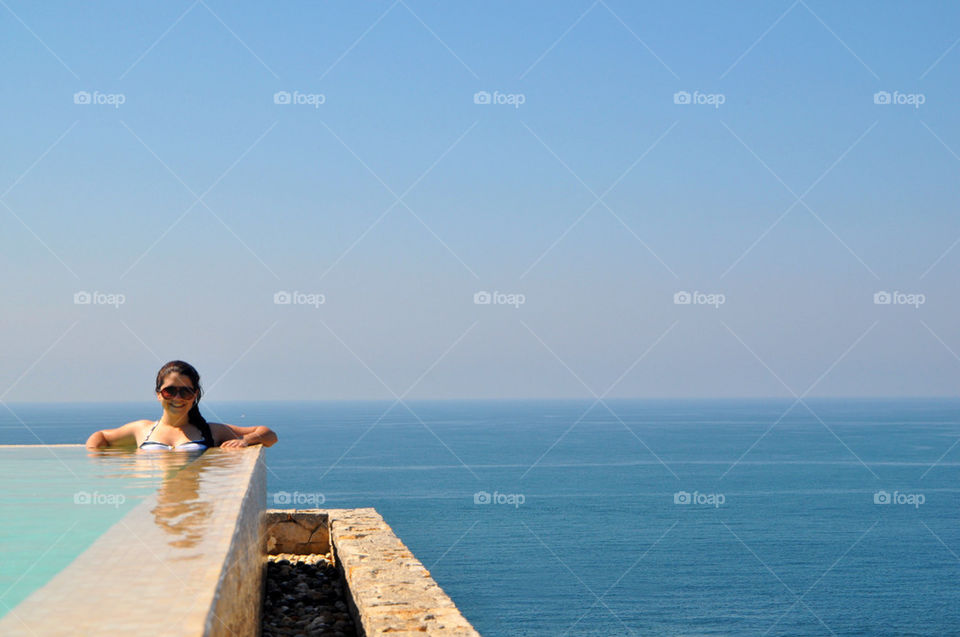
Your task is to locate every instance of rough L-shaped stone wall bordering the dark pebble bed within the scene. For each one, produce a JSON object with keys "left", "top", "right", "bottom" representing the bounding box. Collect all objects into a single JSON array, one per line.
[{"left": 264, "top": 509, "right": 479, "bottom": 637}]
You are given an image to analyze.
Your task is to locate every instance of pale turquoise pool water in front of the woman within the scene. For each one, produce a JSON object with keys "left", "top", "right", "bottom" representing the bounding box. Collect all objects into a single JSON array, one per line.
[{"left": 0, "top": 445, "right": 197, "bottom": 617}]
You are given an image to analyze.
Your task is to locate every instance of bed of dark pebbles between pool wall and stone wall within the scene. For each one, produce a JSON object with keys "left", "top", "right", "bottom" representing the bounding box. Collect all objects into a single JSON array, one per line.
[{"left": 262, "top": 553, "right": 357, "bottom": 637}]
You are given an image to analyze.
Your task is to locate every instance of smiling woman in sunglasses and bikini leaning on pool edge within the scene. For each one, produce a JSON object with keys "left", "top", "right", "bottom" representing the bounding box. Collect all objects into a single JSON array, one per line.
[{"left": 87, "top": 361, "right": 277, "bottom": 451}]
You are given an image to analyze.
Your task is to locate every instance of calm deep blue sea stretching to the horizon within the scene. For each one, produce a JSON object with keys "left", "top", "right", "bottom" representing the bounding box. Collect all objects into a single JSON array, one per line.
[{"left": 0, "top": 399, "right": 960, "bottom": 637}]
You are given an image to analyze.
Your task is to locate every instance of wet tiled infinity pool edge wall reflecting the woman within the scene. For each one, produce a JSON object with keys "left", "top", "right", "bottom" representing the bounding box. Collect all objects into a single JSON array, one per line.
[{"left": 0, "top": 445, "right": 266, "bottom": 637}]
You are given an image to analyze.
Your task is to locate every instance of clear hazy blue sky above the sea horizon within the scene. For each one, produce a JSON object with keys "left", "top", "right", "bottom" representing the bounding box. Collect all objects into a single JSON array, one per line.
[{"left": 0, "top": 0, "right": 960, "bottom": 401}]
